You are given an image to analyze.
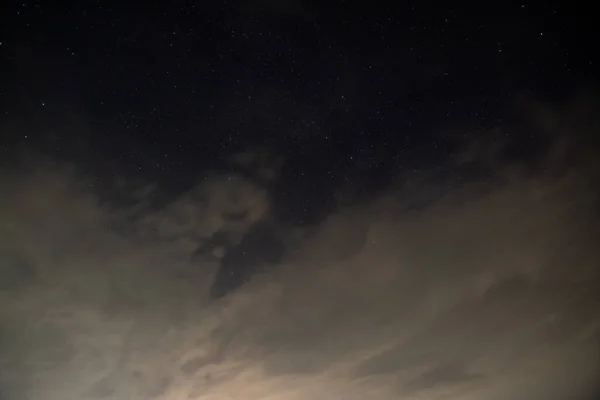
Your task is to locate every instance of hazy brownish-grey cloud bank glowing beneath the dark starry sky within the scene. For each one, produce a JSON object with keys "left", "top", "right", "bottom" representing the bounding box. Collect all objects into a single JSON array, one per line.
[{"left": 0, "top": 95, "right": 600, "bottom": 400}]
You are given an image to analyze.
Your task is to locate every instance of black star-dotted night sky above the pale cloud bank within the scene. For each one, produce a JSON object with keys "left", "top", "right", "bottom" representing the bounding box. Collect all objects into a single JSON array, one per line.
[{"left": 2, "top": 1, "right": 597, "bottom": 200}]
